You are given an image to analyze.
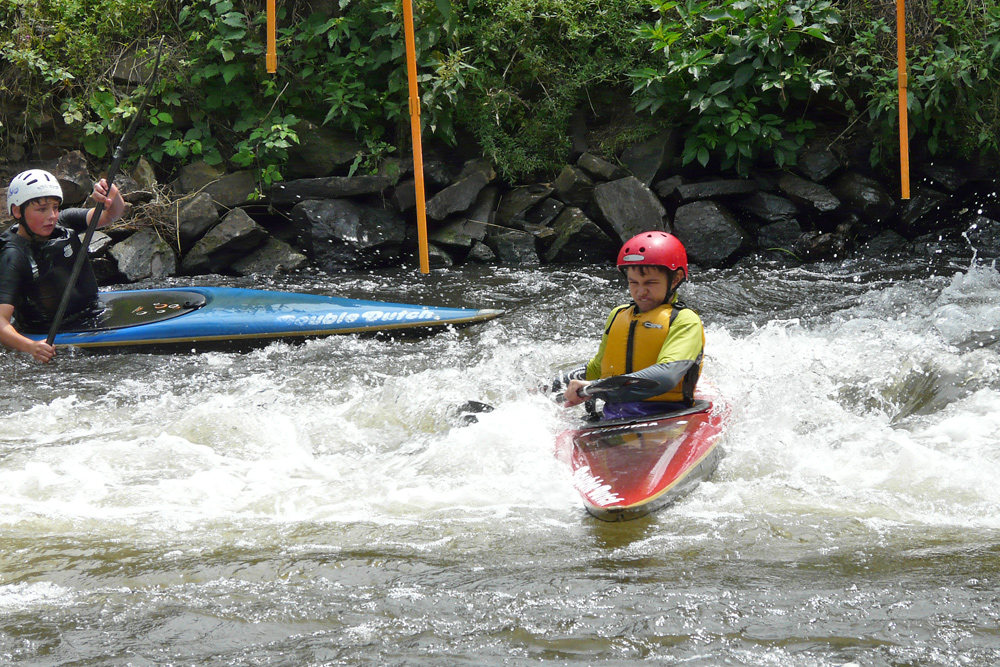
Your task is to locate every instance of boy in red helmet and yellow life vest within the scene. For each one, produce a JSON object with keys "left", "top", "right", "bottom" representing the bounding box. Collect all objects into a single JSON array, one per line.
[{"left": 563, "top": 231, "right": 705, "bottom": 419}]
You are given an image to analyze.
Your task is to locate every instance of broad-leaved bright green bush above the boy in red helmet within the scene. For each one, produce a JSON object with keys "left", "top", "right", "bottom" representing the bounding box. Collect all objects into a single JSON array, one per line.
[{"left": 632, "top": 0, "right": 840, "bottom": 174}]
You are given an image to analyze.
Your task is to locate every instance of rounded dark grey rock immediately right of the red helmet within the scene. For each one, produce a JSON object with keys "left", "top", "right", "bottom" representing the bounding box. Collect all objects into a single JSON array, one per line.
[{"left": 674, "top": 200, "right": 748, "bottom": 268}]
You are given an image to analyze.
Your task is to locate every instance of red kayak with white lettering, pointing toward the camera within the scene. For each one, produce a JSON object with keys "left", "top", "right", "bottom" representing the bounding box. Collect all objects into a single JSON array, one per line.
[{"left": 556, "top": 400, "right": 729, "bottom": 521}]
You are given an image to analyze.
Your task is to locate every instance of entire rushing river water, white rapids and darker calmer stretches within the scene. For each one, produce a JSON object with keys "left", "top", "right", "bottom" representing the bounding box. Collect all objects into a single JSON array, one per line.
[{"left": 0, "top": 254, "right": 1000, "bottom": 667}]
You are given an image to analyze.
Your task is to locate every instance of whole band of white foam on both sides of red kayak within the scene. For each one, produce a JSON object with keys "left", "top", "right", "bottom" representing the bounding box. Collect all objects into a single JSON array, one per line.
[{"left": 0, "top": 266, "right": 1000, "bottom": 527}]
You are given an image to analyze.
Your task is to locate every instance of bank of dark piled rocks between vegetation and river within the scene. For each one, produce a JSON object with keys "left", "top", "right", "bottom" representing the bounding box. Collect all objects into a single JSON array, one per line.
[{"left": 0, "top": 133, "right": 1000, "bottom": 284}]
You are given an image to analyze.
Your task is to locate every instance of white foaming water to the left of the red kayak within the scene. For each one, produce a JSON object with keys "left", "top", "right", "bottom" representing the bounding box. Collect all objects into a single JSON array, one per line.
[{"left": 0, "top": 341, "right": 571, "bottom": 530}]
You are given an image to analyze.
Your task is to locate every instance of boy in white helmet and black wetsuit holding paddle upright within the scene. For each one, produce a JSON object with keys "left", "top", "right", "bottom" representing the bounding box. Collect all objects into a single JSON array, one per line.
[{"left": 0, "top": 169, "right": 125, "bottom": 363}]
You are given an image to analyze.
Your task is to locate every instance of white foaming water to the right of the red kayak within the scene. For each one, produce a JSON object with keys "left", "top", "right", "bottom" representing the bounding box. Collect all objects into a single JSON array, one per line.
[{"left": 699, "top": 260, "right": 1000, "bottom": 529}]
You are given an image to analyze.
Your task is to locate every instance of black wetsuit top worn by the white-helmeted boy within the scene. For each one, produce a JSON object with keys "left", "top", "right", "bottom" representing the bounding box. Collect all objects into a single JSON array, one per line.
[{"left": 0, "top": 208, "right": 98, "bottom": 333}]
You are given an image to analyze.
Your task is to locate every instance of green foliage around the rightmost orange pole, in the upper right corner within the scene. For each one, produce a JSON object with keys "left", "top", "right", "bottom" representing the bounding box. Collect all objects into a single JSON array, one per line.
[{"left": 834, "top": 0, "right": 1000, "bottom": 165}]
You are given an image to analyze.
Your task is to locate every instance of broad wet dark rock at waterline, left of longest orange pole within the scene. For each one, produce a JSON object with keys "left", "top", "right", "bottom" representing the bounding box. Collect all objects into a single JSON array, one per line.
[{"left": 292, "top": 199, "right": 406, "bottom": 271}]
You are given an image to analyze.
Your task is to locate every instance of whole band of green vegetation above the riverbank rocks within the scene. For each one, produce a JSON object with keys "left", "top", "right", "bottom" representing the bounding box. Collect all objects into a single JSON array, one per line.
[{"left": 0, "top": 0, "right": 1000, "bottom": 185}]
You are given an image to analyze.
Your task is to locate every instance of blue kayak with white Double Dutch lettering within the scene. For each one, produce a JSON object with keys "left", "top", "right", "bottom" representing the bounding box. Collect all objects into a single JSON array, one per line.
[{"left": 26, "top": 287, "right": 503, "bottom": 348}]
